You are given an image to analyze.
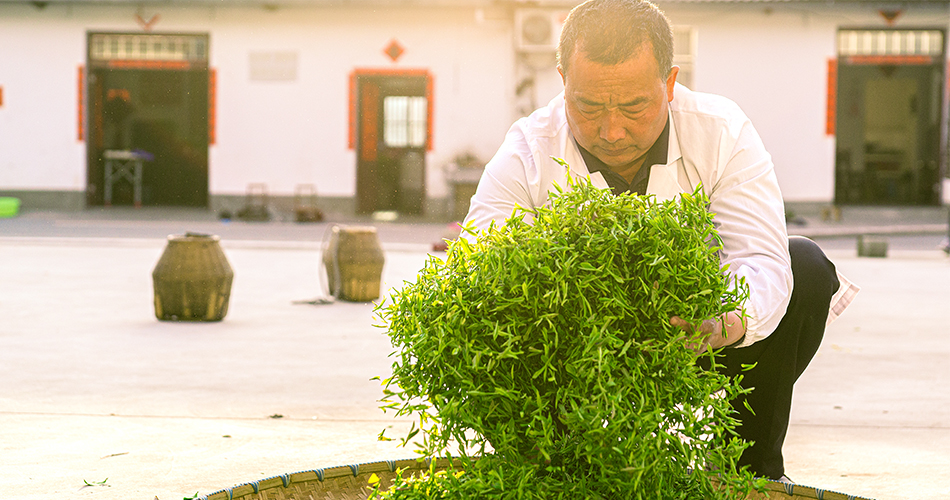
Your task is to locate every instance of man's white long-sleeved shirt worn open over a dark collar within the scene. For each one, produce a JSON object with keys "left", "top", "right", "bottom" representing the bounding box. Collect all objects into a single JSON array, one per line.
[{"left": 465, "top": 84, "right": 853, "bottom": 347}]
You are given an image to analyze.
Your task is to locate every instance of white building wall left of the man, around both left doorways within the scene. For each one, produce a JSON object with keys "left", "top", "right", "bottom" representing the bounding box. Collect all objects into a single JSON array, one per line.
[{"left": 0, "top": 4, "right": 514, "bottom": 203}]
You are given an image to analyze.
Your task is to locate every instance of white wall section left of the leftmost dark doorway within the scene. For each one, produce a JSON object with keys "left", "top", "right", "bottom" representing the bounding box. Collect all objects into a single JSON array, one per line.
[{"left": 0, "top": 4, "right": 86, "bottom": 190}]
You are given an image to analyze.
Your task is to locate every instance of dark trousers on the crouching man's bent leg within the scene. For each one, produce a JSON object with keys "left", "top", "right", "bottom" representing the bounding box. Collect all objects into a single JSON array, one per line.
[{"left": 700, "top": 236, "right": 838, "bottom": 479}]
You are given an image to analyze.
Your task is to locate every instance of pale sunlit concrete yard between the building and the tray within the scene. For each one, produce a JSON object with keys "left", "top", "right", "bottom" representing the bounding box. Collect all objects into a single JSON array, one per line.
[{"left": 0, "top": 205, "right": 950, "bottom": 500}]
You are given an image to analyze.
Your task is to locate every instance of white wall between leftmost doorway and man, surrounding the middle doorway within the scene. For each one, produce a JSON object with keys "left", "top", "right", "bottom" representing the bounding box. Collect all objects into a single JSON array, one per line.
[{"left": 211, "top": 8, "right": 513, "bottom": 197}]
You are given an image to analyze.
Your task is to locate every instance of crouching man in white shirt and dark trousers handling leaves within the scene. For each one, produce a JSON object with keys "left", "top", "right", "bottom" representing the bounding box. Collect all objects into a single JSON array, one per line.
[{"left": 466, "top": 0, "right": 857, "bottom": 481}]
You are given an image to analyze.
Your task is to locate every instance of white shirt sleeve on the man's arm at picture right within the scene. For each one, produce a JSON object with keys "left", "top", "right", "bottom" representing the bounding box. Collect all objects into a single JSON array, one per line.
[{"left": 709, "top": 118, "right": 793, "bottom": 347}]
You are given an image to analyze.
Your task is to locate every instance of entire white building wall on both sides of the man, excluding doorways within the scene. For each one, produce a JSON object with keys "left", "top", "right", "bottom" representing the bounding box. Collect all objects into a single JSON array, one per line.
[{"left": 0, "top": 3, "right": 950, "bottom": 206}]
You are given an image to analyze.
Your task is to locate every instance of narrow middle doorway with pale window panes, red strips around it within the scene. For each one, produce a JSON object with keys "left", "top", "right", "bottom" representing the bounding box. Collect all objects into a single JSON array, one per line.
[{"left": 351, "top": 70, "right": 432, "bottom": 214}]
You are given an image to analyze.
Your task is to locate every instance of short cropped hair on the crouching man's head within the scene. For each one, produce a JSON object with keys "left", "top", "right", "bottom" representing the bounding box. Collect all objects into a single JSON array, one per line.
[{"left": 557, "top": 0, "right": 673, "bottom": 77}]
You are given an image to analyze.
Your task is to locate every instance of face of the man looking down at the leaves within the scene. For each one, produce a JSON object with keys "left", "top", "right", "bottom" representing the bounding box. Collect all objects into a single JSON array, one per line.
[{"left": 558, "top": 42, "right": 679, "bottom": 168}]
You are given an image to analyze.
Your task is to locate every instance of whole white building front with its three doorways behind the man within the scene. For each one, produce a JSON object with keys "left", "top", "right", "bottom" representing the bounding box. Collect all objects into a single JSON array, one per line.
[{"left": 0, "top": 0, "right": 950, "bottom": 218}]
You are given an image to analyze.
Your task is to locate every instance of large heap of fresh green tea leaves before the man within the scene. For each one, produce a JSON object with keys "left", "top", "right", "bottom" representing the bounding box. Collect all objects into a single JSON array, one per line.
[{"left": 374, "top": 172, "right": 764, "bottom": 500}]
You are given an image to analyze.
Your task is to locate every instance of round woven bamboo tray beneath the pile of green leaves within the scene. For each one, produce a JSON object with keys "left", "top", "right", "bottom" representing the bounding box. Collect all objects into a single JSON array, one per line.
[{"left": 200, "top": 459, "right": 870, "bottom": 500}]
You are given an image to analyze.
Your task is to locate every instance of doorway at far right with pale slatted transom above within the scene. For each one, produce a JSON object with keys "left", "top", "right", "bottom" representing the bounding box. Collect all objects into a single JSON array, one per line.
[{"left": 835, "top": 30, "right": 944, "bottom": 206}]
